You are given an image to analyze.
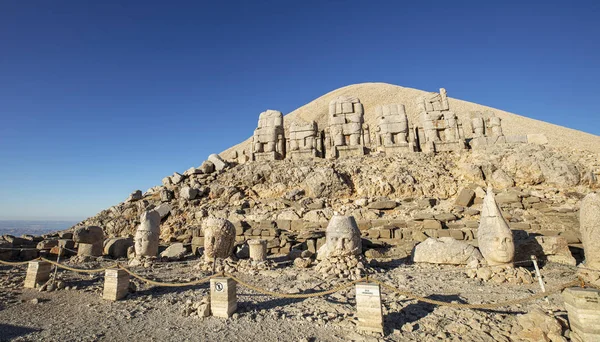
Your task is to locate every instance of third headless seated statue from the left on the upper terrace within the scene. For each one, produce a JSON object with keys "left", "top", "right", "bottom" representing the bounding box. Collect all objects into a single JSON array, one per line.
[{"left": 325, "top": 96, "right": 370, "bottom": 158}]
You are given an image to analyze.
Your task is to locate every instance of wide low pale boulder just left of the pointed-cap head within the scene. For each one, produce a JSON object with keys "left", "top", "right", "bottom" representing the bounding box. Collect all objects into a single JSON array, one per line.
[{"left": 413, "top": 237, "right": 483, "bottom": 265}]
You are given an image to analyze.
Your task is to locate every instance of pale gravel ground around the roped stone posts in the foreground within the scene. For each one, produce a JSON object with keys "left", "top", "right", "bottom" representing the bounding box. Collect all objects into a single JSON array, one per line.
[{"left": 0, "top": 259, "right": 575, "bottom": 341}]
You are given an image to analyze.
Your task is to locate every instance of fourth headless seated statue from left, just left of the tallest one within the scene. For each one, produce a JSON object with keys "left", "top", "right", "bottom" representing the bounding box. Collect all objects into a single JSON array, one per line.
[{"left": 375, "top": 104, "right": 415, "bottom": 154}]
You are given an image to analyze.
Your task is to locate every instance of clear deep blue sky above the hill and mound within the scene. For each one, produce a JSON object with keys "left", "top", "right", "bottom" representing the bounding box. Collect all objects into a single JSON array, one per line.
[{"left": 0, "top": 0, "right": 600, "bottom": 219}]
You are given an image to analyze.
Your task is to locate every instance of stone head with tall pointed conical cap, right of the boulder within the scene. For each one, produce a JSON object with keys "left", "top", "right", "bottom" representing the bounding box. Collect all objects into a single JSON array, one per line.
[{"left": 477, "top": 188, "right": 515, "bottom": 265}]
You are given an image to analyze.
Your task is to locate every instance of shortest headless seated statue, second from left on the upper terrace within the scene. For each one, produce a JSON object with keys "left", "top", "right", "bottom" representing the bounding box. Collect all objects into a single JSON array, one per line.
[{"left": 286, "top": 121, "right": 323, "bottom": 159}]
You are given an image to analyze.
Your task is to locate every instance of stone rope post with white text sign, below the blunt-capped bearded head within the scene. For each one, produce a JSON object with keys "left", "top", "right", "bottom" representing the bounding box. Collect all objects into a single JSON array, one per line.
[{"left": 356, "top": 283, "right": 383, "bottom": 333}]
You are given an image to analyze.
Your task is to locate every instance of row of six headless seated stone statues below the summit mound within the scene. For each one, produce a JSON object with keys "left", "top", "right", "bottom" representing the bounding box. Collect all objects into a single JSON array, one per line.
[{"left": 248, "top": 88, "right": 503, "bottom": 160}]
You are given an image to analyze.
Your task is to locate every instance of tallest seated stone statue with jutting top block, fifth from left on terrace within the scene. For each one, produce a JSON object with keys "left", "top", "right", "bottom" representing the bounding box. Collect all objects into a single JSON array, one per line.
[{"left": 417, "top": 88, "right": 465, "bottom": 153}]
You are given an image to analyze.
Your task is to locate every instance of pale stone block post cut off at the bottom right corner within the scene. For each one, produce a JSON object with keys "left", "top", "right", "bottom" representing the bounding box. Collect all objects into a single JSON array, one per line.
[{"left": 562, "top": 287, "right": 600, "bottom": 342}]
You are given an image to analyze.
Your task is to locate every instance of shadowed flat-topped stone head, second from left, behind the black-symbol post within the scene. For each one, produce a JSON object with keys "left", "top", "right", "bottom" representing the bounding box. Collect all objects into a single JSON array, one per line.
[{"left": 203, "top": 217, "right": 235, "bottom": 261}]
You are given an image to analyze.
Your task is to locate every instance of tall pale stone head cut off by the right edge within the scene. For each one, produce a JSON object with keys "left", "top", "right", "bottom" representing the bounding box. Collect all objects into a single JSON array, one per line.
[{"left": 579, "top": 193, "right": 600, "bottom": 270}]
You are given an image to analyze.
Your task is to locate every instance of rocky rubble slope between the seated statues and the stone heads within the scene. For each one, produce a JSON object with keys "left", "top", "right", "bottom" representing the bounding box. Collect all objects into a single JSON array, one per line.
[{"left": 69, "top": 144, "right": 600, "bottom": 247}]
